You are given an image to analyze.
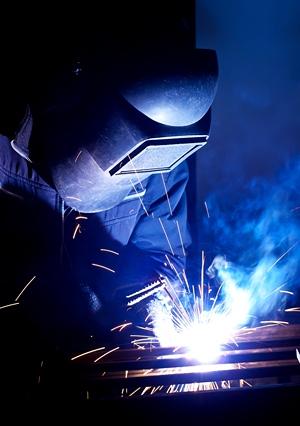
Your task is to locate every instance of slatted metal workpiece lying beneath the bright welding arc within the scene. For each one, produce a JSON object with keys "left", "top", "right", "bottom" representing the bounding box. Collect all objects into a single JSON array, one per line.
[{"left": 38, "top": 324, "right": 300, "bottom": 400}]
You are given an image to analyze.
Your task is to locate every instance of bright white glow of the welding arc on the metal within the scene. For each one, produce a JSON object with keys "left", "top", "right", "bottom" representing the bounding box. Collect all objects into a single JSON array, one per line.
[{"left": 149, "top": 288, "right": 248, "bottom": 363}]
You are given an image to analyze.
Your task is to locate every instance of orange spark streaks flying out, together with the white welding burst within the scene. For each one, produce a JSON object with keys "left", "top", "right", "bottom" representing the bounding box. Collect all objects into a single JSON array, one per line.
[{"left": 60, "top": 156, "right": 300, "bottom": 396}]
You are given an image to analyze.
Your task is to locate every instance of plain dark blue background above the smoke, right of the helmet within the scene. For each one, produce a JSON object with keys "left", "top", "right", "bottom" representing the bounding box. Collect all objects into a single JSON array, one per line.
[{"left": 195, "top": 0, "right": 300, "bottom": 218}]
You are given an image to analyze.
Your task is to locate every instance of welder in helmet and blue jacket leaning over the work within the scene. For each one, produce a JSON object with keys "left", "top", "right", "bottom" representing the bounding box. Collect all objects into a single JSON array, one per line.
[{"left": 0, "top": 1, "right": 218, "bottom": 402}]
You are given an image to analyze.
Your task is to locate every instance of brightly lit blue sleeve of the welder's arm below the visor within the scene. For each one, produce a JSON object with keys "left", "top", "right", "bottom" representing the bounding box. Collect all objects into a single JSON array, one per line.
[{"left": 118, "top": 162, "right": 191, "bottom": 290}]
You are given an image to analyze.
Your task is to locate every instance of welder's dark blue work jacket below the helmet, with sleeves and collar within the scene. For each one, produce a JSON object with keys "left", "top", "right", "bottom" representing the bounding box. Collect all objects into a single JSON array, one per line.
[{"left": 0, "top": 123, "right": 191, "bottom": 350}]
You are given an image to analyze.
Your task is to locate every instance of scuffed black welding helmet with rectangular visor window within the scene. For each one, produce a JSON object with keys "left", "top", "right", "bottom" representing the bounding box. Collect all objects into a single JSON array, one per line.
[{"left": 38, "top": 49, "right": 218, "bottom": 213}]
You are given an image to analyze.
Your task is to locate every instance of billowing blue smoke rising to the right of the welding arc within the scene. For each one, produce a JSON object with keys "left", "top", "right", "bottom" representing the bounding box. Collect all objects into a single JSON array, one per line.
[{"left": 204, "top": 157, "right": 300, "bottom": 319}]
